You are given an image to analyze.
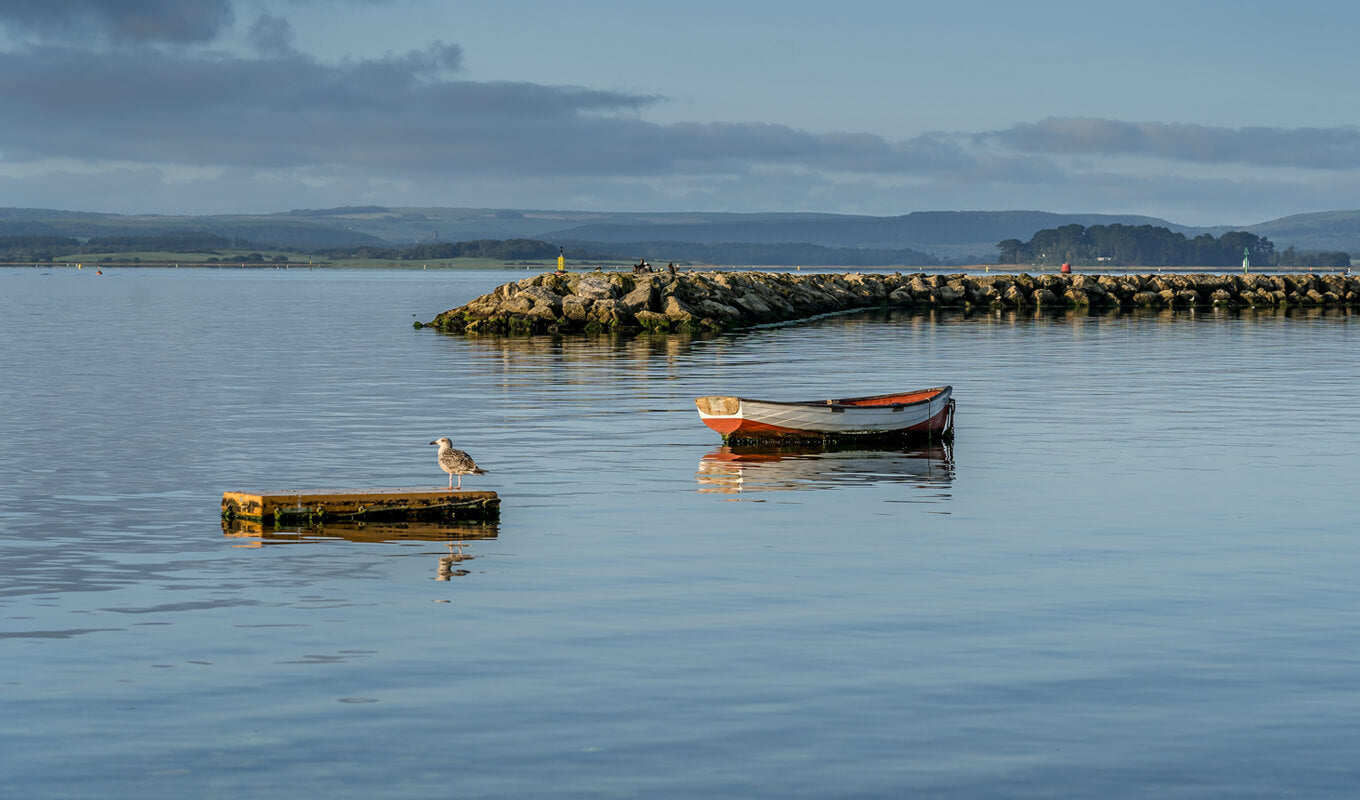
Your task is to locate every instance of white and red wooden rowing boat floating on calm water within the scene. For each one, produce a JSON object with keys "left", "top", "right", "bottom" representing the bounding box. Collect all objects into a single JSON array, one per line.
[{"left": 694, "top": 386, "right": 953, "bottom": 444}]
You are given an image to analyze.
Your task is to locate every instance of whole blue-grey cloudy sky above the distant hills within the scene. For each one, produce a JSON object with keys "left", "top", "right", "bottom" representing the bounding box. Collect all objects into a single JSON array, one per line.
[{"left": 0, "top": 0, "right": 1360, "bottom": 226}]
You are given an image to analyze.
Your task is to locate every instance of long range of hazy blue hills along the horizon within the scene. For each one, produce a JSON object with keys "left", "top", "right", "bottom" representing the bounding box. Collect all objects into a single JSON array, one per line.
[{"left": 0, "top": 205, "right": 1360, "bottom": 263}]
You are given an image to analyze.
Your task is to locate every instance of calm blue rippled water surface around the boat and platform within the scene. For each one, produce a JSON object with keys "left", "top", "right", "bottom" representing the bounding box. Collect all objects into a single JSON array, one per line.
[{"left": 0, "top": 269, "right": 1360, "bottom": 799}]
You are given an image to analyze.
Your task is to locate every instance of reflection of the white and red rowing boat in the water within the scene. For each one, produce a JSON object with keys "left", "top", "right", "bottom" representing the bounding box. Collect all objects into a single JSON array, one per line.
[{"left": 696, "top": 442, "right": 953, "bottom": 494}]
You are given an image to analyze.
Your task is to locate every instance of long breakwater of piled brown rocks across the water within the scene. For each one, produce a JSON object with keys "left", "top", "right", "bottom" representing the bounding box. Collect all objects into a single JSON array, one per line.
[{"left": 427, "top": 272, "right": 1360, "bottom": 333}]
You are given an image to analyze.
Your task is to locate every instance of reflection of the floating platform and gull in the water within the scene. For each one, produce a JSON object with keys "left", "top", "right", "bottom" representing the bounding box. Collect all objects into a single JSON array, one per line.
[{"left": 222, "top": 520, "right": 500, "bottom": 581}]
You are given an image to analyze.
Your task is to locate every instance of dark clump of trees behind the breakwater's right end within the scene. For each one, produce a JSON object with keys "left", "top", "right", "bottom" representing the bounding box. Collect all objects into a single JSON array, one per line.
[{"left": 997, "top": 224, "right": 1350, "bottom": 267}]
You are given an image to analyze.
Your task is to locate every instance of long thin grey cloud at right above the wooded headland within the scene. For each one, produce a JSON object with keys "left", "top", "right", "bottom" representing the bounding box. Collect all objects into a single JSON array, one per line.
[{"left": 978, "top": 118, "right": 1360, "bottom": 169}]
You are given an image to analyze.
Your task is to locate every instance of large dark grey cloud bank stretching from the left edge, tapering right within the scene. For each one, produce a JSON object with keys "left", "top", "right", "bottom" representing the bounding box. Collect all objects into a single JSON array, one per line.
[{"left": 0, "top": 44, "right": 1044, "bottom": 180}]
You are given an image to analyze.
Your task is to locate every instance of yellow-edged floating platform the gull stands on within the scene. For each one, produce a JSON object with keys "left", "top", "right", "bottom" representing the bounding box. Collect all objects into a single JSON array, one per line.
[{"left": 222, "top": 487, "right": 500, "bottom": 525}]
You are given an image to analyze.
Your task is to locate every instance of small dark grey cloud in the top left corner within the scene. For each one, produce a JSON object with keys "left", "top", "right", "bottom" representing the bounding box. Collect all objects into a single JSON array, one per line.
[{"left": 0, "top": 0, "right": 235, "bottom": 44}]
